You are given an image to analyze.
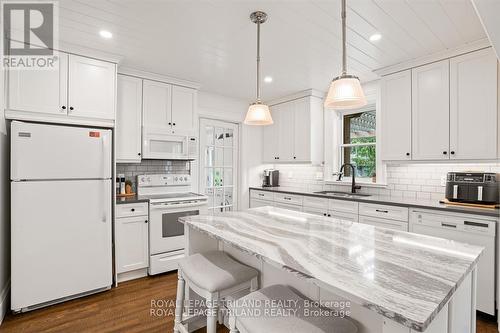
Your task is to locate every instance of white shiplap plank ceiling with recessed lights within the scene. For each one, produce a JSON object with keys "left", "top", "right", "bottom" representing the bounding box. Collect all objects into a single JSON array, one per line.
[{"left": 59, "top": 0, "right": 486, "bottom": 101}]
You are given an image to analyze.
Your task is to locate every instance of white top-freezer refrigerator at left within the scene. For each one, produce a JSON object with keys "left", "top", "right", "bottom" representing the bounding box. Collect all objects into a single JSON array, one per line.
[{"left": 11, "top": 121, "right": 112, "bottom": 312}]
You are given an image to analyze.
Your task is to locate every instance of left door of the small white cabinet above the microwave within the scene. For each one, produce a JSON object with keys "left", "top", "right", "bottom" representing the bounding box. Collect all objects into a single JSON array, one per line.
[{"left": 142, "top": 80, "right": 172, "bottom": 129}]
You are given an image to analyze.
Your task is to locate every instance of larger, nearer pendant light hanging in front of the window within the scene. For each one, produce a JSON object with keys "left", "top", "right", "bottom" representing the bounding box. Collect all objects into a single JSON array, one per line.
[{"left": 325, "top": 0, "right": 366, "bottom": 110}]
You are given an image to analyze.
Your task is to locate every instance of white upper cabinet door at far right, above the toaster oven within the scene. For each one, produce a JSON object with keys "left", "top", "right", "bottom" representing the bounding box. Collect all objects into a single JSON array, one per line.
[{"left": 450, "top": 49, "right": 498, "bottom": 159}]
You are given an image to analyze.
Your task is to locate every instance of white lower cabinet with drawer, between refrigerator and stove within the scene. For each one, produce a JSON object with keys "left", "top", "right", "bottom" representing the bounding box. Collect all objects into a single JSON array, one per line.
[{"left": 115, "top": 203, "right": 149, "bottom": 281}]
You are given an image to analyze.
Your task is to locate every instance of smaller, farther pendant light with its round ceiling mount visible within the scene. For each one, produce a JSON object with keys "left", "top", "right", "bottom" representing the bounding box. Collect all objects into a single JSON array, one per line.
[{"left": 244, "top": 11, "right": 273, "bottom": 126}]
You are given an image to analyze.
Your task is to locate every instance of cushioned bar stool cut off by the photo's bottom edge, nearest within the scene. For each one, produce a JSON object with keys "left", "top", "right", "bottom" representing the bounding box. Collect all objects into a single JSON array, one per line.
[{"left": 229, "top": 285, "right": 358, "bottom": 333}]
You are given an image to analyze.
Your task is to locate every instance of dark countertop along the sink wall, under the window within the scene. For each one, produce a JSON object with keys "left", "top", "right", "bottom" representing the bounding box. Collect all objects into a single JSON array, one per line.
[{"left": 250, "top": 186, "right": 500, "bottom": 217}]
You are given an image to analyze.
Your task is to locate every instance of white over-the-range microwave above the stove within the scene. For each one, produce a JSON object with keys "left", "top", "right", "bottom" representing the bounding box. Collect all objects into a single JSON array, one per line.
[{"left": 142, "top": 128, "right": 189, "bottom": 160}]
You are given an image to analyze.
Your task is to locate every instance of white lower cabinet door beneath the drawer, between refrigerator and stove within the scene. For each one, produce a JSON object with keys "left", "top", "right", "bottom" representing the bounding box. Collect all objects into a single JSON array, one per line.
[{"left": 115, "top": 216, "right": 149, "bottom": 273}]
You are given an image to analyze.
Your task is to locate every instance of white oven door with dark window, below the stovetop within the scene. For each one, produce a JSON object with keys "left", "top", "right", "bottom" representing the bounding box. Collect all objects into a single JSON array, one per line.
[{"left": 149, "top": 201, "right": 207, "bottom": 255}]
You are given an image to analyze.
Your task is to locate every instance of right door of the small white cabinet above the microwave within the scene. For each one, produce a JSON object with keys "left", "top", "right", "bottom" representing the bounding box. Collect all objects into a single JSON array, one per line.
[{"left": 172, "top": 86, "right": 196, "bottom": 131}]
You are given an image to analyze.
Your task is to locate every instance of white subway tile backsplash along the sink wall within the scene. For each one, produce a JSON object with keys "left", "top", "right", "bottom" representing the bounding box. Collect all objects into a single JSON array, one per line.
[{"left": 275, "top": 163, "right": 500, "bottom": 200}]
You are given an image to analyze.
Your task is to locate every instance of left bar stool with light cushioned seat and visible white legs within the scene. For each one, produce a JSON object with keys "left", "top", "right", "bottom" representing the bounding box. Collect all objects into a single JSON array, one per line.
[{"left": 174, "top": 251, "right": 259, "bottom": 333}]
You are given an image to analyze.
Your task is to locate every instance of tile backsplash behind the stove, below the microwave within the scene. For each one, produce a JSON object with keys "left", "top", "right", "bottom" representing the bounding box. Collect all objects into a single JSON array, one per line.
[{"left": 116, "top": 160, "right": 191, "bottom": 192}]
